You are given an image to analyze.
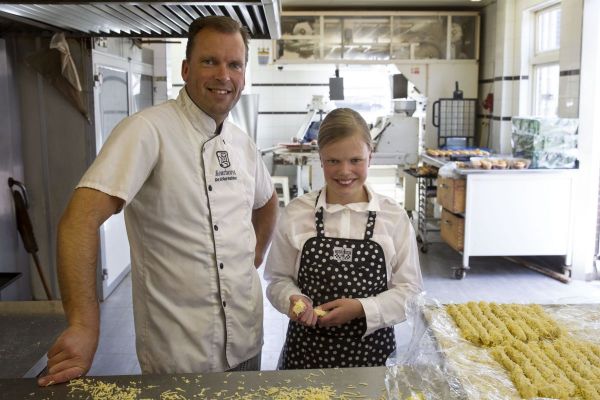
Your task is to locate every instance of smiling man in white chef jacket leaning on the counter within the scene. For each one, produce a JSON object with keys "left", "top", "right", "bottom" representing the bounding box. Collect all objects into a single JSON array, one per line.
[{"left": 38, "top": 17, "right": 277, "bottom": 385}]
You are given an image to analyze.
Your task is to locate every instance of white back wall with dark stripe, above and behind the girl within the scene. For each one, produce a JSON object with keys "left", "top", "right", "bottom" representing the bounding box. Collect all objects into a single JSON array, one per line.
[{"left": 246, "top": 40, "right": 400, "bottom": 185}]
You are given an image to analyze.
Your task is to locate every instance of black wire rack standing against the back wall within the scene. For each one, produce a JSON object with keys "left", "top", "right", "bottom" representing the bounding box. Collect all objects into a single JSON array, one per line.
[{"left": 432, "top": 82, "right": 477, "bottom": 148}]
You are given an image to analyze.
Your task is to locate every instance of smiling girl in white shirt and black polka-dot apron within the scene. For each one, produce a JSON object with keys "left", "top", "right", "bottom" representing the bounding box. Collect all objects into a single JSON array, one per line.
[{"left": 265, "top": 108, "right": 422, "bottom": 369}]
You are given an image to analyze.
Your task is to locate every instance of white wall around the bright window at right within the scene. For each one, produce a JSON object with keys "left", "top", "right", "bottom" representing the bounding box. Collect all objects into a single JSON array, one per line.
[{"left": 479, "top": 0, "right": 600, "bottom": 279}]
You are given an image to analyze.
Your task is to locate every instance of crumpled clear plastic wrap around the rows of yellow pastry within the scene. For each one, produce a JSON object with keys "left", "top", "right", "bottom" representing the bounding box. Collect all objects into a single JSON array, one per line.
[{"left": 386, "top": 296, "right": 600, "bottom": 400}]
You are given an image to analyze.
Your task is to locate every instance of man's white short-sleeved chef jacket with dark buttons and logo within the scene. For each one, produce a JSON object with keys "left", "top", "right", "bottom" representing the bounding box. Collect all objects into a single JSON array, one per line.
[{"left": 78, "top": 88, "right": 273, "bottom": 373}]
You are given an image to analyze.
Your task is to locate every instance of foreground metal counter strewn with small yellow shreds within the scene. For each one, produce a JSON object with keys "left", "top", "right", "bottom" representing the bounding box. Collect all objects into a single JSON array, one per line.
[{"left": 0, "top": 367, "right": 386, "bottom": 400}]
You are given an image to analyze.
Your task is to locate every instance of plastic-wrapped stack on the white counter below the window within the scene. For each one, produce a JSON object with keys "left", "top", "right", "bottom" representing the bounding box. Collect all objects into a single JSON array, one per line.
[{"left": 512, "top": 117, "right": 579, "bottom": 168}]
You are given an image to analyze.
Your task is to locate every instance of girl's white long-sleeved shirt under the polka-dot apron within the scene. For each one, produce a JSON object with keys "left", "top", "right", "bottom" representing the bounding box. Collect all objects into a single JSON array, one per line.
[{"left": 265, "top": 186, "right": 423, "bottom": 336}]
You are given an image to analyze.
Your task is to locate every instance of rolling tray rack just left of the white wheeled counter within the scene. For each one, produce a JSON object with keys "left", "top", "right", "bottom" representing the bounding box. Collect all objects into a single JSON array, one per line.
[{"left": 404, "top": 167, "right": 440, "bottom": 253}]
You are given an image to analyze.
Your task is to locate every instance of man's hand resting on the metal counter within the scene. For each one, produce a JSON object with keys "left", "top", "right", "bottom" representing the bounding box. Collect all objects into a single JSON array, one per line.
[{"left": 38, "top": 326, "right": 98, "bottom": 386}]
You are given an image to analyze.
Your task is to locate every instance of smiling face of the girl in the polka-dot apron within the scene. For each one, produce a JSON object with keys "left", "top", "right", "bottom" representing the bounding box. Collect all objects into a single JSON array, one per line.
[{"left": 319, "top": 133, "right": 371, "bottom": 204}]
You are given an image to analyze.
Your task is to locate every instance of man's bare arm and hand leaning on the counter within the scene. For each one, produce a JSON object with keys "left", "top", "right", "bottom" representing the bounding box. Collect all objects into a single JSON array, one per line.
[{"left": 38, "top": 188, "right": 119, "bottom": 386}]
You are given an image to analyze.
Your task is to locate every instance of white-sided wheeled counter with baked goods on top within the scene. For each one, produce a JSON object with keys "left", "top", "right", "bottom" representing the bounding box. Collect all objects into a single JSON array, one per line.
[{"left": 422, "top": 155, "right": 578, "bottom": 282}]
